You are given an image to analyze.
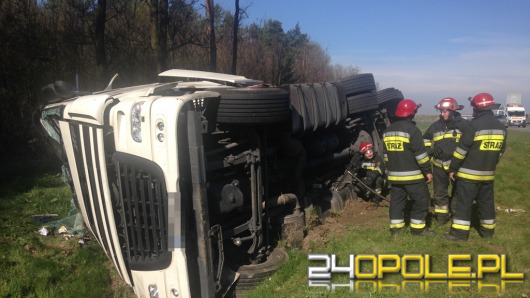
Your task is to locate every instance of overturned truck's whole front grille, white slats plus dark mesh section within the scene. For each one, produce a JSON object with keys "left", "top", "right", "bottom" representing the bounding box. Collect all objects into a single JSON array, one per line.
[{"left": 69, "top": 123, "right": 171, "bottom": 277}]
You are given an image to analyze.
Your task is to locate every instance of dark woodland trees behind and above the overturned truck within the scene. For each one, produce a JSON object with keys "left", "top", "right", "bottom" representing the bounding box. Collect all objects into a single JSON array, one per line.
[{"left": 0, "top": 0, "right": 359, "bottom": 157}]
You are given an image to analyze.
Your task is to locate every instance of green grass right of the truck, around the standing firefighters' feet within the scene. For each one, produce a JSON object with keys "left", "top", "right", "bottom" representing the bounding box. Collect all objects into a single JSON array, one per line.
[{"left": 248, "top": 127, "right": 530, "bottom": 298}]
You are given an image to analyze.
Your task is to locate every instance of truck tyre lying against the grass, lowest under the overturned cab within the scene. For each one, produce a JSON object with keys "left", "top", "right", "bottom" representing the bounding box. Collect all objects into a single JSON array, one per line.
[{"left": 235, "top": 248, "right": 289, "bottom": 297}]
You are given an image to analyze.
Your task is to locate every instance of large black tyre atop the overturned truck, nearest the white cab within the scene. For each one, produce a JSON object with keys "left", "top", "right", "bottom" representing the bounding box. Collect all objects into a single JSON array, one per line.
[{"left": 217, "top": 88, "right": 291, "bottom": 124}]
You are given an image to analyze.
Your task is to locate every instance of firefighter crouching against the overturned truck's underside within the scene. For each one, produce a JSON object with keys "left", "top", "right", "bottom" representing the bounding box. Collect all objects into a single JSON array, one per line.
[{"left": 356, "top": 142, "right": 387, "bottom": 204}]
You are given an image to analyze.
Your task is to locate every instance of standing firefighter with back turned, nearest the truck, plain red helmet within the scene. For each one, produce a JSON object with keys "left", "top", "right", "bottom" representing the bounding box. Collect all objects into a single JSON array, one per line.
[{"left": 383, "top": 99, "right": 433, "bottom": 236}]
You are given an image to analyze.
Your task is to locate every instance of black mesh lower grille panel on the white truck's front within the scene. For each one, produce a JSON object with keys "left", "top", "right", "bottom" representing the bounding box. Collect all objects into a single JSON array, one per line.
[{"left": 114, "top": 152, "right": 171, "bottom": 270}]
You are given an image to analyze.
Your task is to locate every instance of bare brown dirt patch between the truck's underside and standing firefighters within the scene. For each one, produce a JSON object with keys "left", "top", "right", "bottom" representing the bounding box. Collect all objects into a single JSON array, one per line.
[{"left": 302, "top": 197, "right": 389, "bottom": 251}]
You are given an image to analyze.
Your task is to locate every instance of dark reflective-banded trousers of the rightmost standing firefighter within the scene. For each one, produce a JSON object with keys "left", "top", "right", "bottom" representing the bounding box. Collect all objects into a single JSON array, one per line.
[{"left": 450, "top": 179, "right": 495, "bottom": 239}]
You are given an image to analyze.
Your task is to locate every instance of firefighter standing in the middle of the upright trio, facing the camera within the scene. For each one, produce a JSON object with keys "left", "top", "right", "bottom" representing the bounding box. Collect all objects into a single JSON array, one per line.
[{"left": 423, "top": 97, "right": 469, "bottom": 225}]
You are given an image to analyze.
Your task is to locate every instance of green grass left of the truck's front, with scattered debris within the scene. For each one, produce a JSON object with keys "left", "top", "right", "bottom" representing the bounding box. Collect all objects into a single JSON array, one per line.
[{"left": 0, "top": 160, "right": 134, "bottom": 297}]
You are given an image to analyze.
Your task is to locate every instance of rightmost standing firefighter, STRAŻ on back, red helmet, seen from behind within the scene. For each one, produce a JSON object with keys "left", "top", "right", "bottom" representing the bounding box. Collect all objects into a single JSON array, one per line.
[{"left": 446, "top": 93, "right": 507, "bottom": 241}]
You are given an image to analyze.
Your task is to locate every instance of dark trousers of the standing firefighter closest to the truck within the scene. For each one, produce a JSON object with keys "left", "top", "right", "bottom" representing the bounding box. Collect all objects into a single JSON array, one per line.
[{"left": 390, "top": 182, "right": 430, "bottom": 232}]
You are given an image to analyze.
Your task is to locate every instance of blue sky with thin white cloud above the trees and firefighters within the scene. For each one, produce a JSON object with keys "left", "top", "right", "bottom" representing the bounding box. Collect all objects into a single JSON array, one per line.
[{"left": 214, "top": 0, "right": 530, "bottom": 114}]
